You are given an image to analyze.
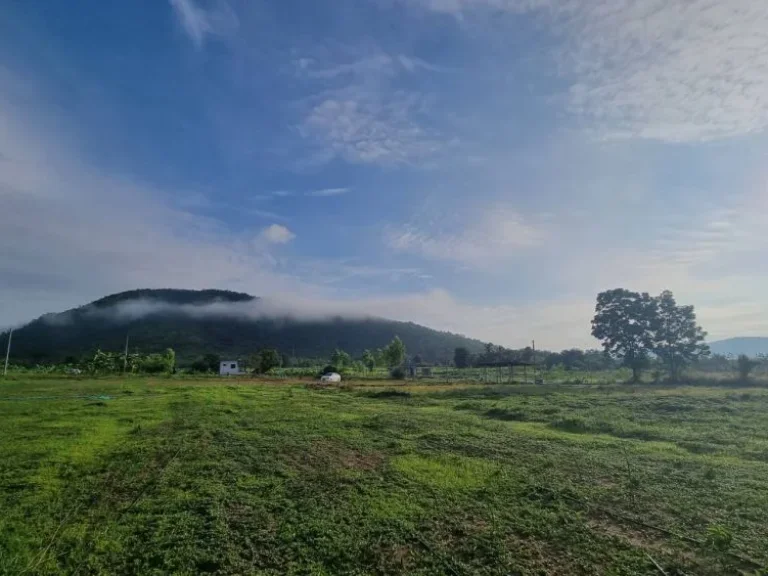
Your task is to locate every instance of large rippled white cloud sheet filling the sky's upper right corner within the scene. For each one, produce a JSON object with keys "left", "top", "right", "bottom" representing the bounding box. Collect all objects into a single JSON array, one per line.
[{"left": 419, "top": 0, "right": 768, "bottom": 142}]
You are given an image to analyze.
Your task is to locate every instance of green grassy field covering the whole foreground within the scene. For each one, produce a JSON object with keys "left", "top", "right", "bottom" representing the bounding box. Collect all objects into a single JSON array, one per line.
[{"left": 0, "top": 379, "right": 768, "bottom": 576}]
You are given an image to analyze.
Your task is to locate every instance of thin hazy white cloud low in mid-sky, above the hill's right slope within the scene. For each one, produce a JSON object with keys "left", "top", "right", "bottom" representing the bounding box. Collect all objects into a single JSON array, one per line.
[{"left": 385, "top": 206, "right": 547, "bottom": 267}]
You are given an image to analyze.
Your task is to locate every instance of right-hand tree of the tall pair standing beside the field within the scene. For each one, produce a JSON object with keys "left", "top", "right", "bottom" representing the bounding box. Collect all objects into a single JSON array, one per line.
[{"left": 653, "top": 290, "right": 709, "bottom": 380}]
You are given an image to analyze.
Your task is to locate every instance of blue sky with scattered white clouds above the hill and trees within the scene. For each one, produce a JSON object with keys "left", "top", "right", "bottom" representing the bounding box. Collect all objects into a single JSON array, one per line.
[{"left": 0, "top": 0, "right": 768, "bottom": 350}]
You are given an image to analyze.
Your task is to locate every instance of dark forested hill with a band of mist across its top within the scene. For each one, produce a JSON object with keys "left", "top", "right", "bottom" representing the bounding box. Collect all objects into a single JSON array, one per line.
[{"left": 7, "top": 289, "right": 483, "bottom": 364}]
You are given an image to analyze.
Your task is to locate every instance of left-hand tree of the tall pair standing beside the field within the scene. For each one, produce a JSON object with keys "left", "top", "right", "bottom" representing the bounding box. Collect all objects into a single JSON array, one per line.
[{"left": 592, "top": 288, "right": 657, "bottom": 381}]
